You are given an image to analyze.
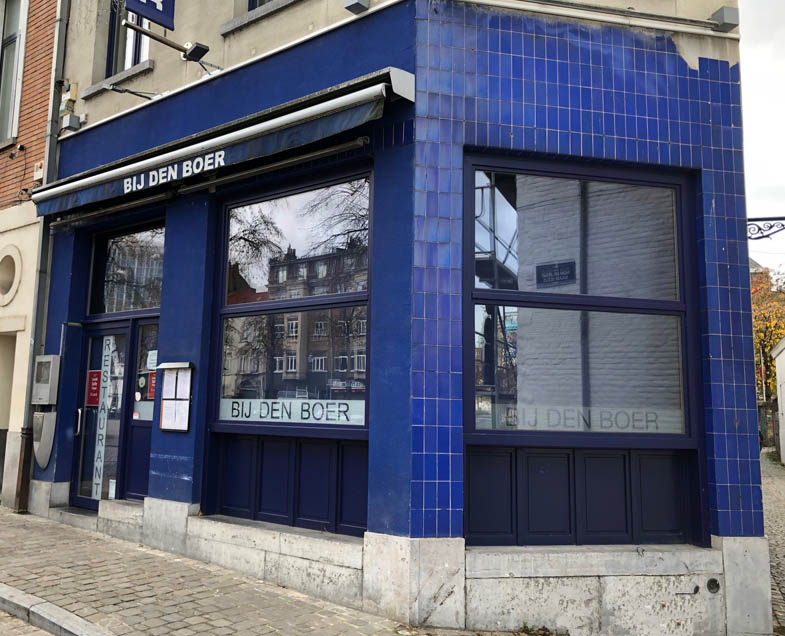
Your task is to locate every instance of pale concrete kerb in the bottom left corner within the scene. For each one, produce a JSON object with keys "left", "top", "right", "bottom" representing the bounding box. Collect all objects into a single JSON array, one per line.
[{"left": 0, "top": 583, "right": 112, "bottom": 636}]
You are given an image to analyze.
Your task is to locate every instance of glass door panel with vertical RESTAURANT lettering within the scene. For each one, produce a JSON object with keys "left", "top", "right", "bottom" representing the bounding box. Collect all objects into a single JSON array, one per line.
[{"left": 77, "top": 333, "right": 126, "bottom": 501}]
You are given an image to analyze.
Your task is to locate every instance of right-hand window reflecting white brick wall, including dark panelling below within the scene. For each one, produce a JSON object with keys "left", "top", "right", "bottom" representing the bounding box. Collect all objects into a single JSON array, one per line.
[{"left": 467, "top": 168, "right": 700, "bottom": 544}]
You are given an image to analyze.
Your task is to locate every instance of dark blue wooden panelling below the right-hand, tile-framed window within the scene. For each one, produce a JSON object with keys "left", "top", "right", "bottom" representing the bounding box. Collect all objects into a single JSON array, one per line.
[{"left": 466, "top": 447, "right": 700, "bottom": 545}]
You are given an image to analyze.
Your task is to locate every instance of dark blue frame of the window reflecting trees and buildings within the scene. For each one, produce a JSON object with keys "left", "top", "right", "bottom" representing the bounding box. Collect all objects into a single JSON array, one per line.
[{"left": 209, "top": 165, "right": 374, "bottom": 440}]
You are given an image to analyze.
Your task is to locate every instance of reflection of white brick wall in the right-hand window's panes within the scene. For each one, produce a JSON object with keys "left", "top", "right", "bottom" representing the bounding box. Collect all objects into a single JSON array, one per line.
[{"left": 475, "top": 172, "right": 682, "bottom": 431}]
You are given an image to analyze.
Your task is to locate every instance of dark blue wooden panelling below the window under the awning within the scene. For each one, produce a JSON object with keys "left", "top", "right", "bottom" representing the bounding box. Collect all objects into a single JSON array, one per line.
[{"left": 216, "top": 435, "right": 368, "bottom": 536}]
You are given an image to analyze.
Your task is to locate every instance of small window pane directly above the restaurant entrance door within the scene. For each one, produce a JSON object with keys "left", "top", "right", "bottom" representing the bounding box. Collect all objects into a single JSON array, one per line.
[{"left": 90, "top": 226, "right": 165, "bottom": 314}]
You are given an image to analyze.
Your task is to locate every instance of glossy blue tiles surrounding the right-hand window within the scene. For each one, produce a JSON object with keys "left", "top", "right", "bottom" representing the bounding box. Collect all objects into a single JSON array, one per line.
[{"left": 411, "top": 2, "right": 763, "bottom": 536}]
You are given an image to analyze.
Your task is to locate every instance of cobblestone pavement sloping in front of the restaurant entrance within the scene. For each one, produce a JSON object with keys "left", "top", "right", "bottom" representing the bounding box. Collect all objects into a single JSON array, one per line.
[{"left": 0, "top": 510, "right": 508, "bottom": 636}]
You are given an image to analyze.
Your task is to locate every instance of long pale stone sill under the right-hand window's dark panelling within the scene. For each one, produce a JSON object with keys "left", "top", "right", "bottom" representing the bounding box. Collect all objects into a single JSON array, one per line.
[{"left": 466, "top": 545, "right": 723, "bottom": 579}]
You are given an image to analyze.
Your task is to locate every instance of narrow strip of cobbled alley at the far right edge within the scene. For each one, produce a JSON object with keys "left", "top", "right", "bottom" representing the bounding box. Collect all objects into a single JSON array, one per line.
[{"left": 760, "top": 449, "right": 785, "bottom": 634}]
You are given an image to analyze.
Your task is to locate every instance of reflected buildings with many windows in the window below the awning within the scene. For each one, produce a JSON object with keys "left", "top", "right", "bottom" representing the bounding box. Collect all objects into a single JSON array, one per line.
[{"left": 224, "top": 241, "right": 368, "bottom": 399}]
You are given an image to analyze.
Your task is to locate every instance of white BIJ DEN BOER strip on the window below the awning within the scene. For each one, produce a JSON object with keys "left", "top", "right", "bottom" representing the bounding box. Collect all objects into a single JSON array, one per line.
[{"left": 220, "top": 398, "right": 365, "bottom": 426}]
